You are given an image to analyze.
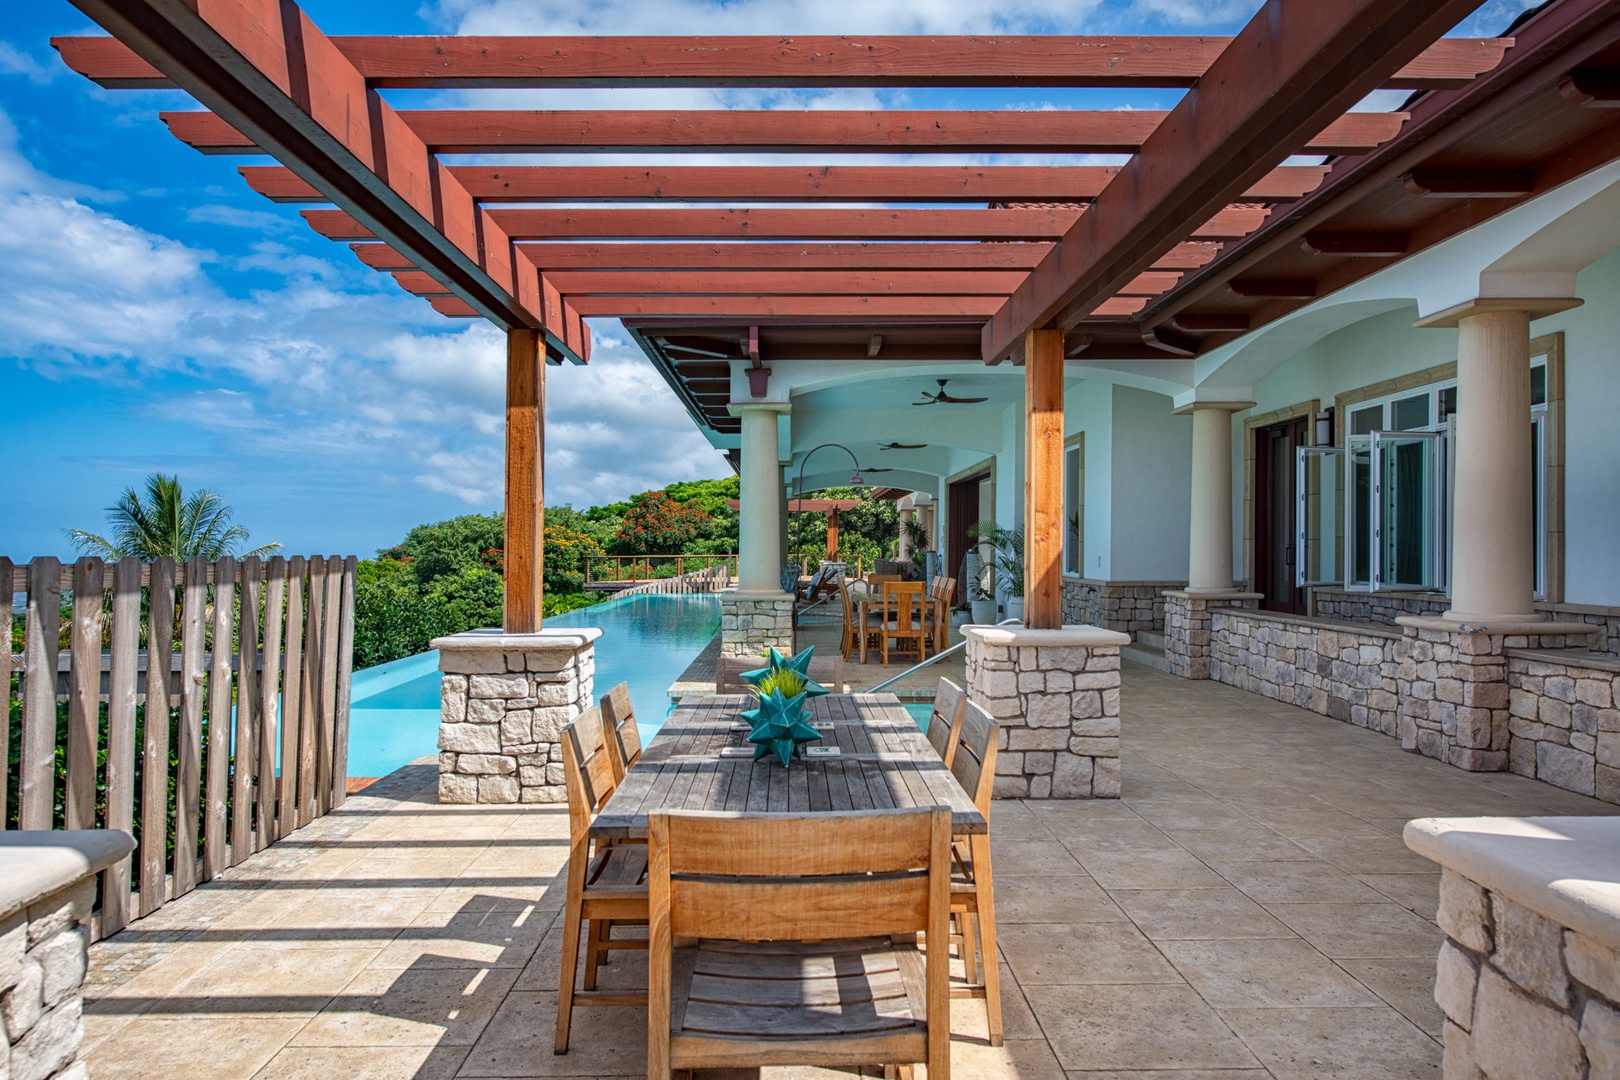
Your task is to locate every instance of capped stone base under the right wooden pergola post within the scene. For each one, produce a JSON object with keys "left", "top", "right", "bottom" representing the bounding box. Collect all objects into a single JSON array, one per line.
[{"left": 962, "top": 627, "right": 1131, "bottom": 798}]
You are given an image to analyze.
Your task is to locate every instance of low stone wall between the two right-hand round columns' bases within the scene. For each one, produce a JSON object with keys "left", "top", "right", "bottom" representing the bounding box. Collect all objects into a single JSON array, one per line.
[{"left": 1209, "top": 609, "right": 1403, "bottom": 735}]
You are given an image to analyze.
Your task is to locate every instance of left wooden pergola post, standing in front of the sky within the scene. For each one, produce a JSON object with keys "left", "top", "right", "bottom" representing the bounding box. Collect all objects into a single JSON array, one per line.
[{"left": 504, "top": 327, "right": 546, "bottom": 633}]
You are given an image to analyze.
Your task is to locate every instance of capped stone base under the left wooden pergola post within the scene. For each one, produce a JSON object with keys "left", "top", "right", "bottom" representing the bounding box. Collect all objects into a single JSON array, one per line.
[{"left": 433, "top": 627, "right": 603, "bottom": 803}]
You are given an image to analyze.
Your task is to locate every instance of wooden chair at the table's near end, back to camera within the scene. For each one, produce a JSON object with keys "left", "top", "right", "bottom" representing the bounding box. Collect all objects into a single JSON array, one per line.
[{"left": 646, "top": 806, "right": 951, "bottom": 1080}]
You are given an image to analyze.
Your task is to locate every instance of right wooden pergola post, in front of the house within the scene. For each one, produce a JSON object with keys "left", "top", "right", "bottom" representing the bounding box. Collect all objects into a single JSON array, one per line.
[{"left": 1024, "top": 330, "right": 1063, "bottom": 630}]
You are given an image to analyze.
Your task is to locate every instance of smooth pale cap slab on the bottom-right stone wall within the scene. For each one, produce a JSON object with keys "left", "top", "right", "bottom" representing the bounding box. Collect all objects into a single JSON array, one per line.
[{"left": 1403, "top": 818, "right": 1620, "bottom": 949}]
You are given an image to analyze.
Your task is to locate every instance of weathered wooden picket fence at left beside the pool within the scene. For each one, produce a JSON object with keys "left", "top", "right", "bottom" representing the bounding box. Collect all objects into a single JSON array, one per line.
[{"left": 0, "top": 555, "right": 356, "bottom": 936}]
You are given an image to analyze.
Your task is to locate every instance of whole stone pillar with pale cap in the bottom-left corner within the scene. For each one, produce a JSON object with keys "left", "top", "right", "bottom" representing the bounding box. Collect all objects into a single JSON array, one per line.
[{"left": 0, "top": 831, "right": 134, "bottom": 1080}]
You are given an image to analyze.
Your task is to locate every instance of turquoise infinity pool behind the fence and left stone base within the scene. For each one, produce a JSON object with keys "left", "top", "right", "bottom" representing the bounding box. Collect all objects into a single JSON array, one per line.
[{"left": 348, "top": 594, "right": 719, "bottom": 776}]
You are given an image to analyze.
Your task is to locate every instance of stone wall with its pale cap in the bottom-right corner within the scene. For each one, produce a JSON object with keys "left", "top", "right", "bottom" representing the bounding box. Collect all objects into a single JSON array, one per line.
[{"left": 1406, "top": 818, "right": 1620, "bottom": 1080}]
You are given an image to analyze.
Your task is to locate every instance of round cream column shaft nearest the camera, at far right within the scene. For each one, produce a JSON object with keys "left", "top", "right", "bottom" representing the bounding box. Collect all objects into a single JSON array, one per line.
[{"left": 1445, "top": 311, "right": 1536, "bottom": 622}]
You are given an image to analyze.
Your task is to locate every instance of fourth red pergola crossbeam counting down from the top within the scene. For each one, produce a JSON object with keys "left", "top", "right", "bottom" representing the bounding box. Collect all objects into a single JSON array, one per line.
[{"left": 301, "top": 207, "right": 1267, "bottom": 241}]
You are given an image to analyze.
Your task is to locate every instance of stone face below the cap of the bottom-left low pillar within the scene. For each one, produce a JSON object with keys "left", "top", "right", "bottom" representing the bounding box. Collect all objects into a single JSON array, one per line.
[{"left": 0, "top": 878, "right": 96, "bottom": 1080}]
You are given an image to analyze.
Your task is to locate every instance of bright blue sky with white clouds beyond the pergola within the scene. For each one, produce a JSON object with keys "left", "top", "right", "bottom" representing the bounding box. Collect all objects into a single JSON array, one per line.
[{"left": 0, "top": 0, "right": 1526, "bottom": 559}]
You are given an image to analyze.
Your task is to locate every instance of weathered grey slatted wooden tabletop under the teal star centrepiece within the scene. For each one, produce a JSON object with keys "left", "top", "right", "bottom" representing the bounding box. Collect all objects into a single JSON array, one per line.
[{"left": 591, "top": 693, "right": 988, "bottom": 840}]
